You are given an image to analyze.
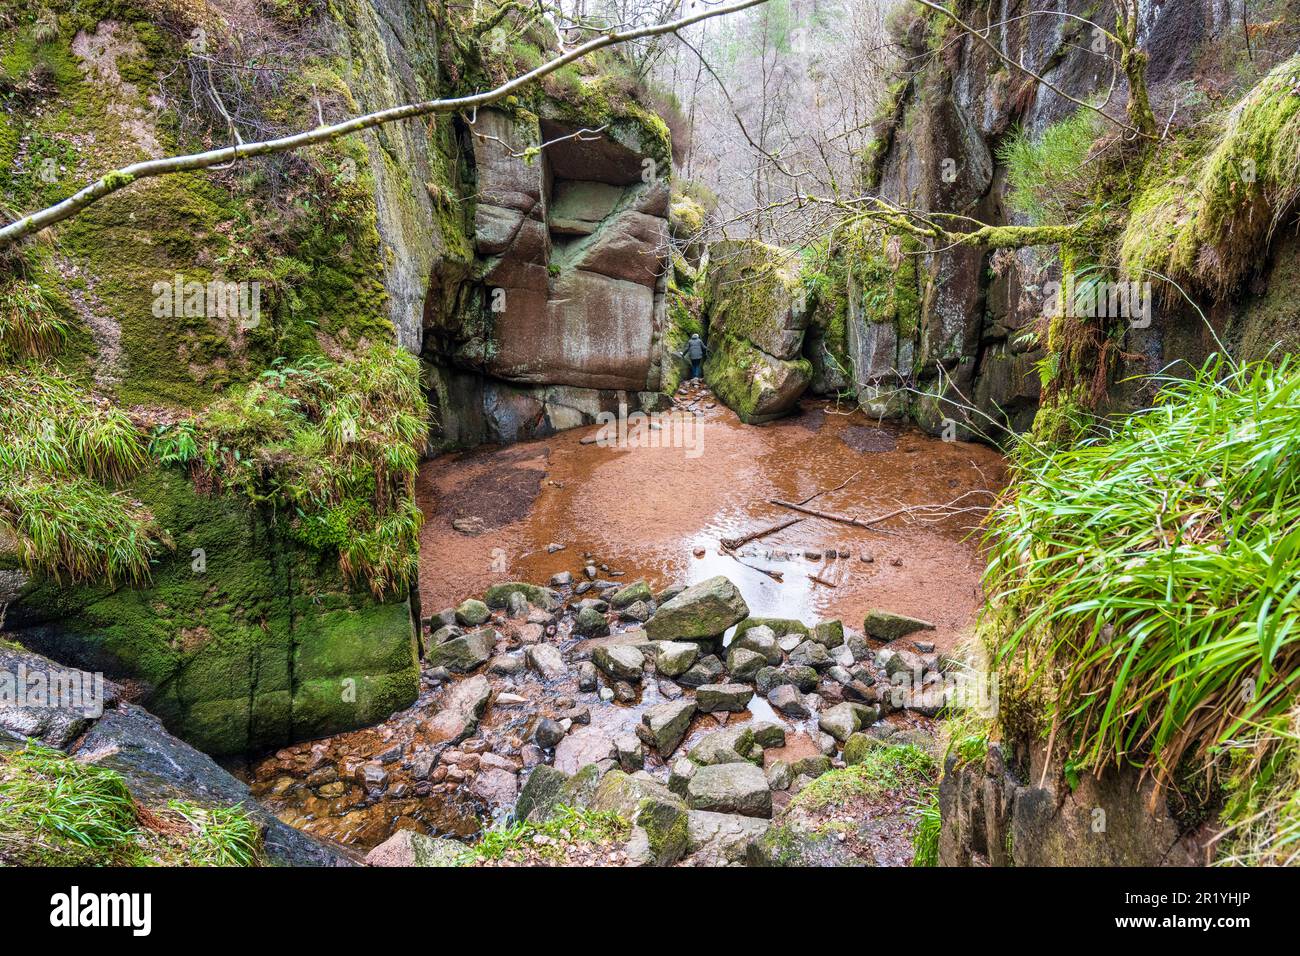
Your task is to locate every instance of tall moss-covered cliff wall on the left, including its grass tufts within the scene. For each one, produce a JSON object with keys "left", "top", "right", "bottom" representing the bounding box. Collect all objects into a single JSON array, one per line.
[{"left": 0, "top": 0, "right": 431, "bottom": 753}]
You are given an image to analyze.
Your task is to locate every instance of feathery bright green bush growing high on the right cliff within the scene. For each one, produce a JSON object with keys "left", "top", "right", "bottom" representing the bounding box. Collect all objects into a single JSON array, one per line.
[{"left": 998, "top": 109, "right": 1101, "bottom": 225}]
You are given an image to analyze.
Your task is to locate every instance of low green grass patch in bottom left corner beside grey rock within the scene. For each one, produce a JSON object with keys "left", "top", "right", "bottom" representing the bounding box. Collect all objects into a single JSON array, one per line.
[{"left": 0, "top": 741, "right": 261, "bottom": 866}]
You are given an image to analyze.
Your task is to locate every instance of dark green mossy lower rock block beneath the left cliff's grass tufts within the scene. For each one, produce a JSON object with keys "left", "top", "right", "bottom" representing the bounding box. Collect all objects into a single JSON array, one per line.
[{"left": 7, "top": 472, "right": 419, "bottom": 753}]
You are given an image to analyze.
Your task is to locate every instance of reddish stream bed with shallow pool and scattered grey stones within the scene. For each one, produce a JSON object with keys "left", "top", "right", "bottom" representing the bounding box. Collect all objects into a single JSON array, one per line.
[{"left": 244, "top": 385, "right": 996, "bottom": 865}]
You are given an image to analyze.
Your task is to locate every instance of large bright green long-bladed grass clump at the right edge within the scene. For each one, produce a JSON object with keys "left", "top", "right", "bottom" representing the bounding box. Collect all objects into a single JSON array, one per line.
[{"left": 985, "top": 360, "right": 1300, "bottom": 806}]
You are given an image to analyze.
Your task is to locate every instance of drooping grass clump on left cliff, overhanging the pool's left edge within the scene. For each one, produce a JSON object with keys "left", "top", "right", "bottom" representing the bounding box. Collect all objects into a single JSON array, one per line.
[{"left": 151, "top": 345, "right": 426, "bottom": 597}]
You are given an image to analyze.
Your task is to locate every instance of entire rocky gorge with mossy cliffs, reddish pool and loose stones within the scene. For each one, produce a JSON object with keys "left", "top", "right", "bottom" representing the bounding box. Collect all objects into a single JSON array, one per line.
[{"left": 0, "top": 0, "right": 1300, "bottom": 865}]
